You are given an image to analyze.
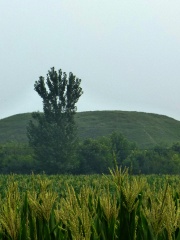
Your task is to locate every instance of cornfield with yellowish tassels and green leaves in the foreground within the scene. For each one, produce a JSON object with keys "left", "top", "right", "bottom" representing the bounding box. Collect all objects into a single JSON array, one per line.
[{"left": 0, "top": 168, "right": 180, "bottom": 240}]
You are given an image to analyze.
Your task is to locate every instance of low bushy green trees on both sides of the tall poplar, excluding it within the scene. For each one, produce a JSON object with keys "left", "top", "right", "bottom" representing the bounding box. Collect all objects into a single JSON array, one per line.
[{"left": 0, "top": 138, "right": 180, "bottom": 174}]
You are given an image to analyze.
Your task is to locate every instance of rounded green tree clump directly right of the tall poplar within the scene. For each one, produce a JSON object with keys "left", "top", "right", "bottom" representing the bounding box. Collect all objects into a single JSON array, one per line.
[{"left": 78, "top": 132, "right": 135, "bottom": 173}]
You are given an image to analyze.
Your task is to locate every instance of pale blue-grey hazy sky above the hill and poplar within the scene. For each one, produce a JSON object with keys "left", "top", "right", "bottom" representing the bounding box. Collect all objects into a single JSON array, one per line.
[{"left": 0, "top": 0, "right": 180, "bottom": 120}]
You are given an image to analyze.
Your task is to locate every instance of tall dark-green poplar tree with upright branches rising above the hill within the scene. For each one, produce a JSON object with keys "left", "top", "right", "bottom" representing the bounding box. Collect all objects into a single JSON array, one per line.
[{"left": 27, "top": 67, "right": 83, "bottom": 173}]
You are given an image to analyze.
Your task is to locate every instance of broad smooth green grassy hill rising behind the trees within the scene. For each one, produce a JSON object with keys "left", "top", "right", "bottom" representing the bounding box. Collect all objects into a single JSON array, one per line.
[{"left": 0, "top": 111, "right": 180, "bottom": 148}]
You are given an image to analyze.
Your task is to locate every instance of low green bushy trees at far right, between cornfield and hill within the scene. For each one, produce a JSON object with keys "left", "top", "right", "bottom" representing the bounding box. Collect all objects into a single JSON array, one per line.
[{"left": 123, "top": 143, "right": 180, "bottom": 174}]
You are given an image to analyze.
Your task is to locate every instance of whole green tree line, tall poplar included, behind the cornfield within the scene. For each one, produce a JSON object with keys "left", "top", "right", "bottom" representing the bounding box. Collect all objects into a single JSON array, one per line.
[{"left": 0, "top": 68, "right": 180, "bottom": 174}]
